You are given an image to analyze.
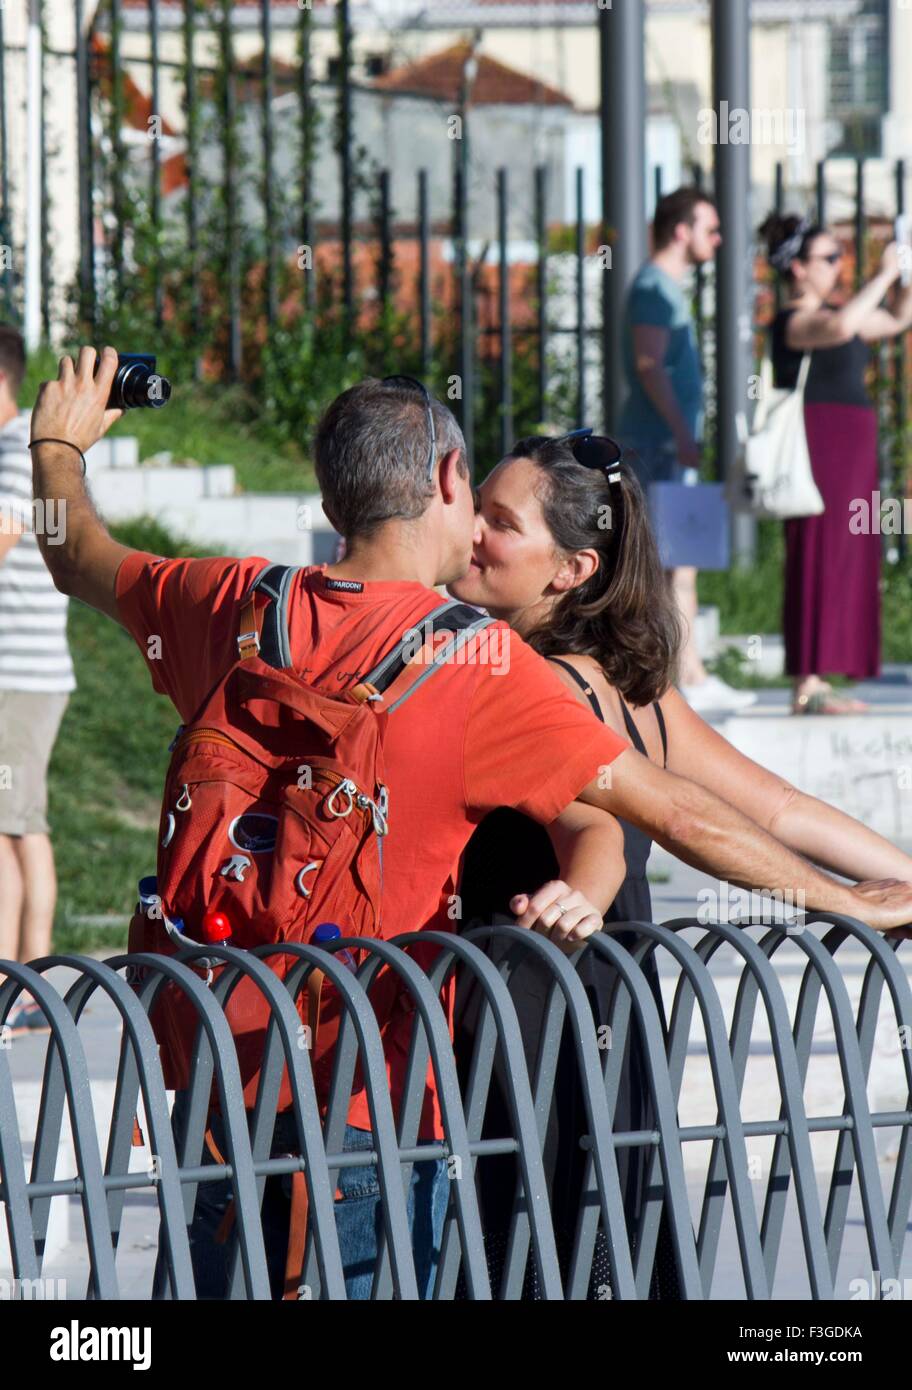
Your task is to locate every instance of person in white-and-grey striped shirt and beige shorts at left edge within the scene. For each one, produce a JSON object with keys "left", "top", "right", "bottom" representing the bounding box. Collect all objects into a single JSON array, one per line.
[{"left": 0, "top": 324, "right": 76, "bottom": 1033}]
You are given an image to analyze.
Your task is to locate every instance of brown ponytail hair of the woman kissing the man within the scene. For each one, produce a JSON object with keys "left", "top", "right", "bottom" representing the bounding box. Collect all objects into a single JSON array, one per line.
[{"left": 507, "top": 435, "right": 681, "bottom": 705}]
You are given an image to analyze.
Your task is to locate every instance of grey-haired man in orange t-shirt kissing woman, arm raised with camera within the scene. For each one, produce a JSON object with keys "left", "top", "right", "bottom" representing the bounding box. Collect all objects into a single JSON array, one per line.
[{"left": 32, "top": 348, "right": 912, "bottom": 1297}]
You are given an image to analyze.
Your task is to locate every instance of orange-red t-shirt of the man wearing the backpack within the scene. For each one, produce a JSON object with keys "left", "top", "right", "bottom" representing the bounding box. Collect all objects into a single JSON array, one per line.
[{"left": 117, "top": 550, "right": 627, "bottom": 1138}]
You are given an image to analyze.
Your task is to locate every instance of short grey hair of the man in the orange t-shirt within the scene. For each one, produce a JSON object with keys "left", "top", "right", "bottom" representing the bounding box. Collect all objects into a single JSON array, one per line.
[{"left": 314, "top": 377, "right": 469, "bottom": 541}]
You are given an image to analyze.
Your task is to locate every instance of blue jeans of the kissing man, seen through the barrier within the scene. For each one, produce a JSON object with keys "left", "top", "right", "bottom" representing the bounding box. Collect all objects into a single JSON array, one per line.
[{"left": 153, "top": 1091, "right": 449, "bottom": 1300}]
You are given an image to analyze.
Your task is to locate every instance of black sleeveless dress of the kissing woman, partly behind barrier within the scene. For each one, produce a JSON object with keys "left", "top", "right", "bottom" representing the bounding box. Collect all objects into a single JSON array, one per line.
[{"left": 455, "top": 662, "right": 681, "bottom": 1300}]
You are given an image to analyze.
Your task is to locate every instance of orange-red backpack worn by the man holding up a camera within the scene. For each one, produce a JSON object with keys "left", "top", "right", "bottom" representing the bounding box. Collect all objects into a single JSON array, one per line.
[{"left": 129, "top": 566, "right": 492, "bottom": 1111}]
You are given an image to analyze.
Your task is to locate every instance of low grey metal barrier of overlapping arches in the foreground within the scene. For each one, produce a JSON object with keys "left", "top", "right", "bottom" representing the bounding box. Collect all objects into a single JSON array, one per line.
[{"left": 0, "top": 913, "right": 912, "bottom": 1300}]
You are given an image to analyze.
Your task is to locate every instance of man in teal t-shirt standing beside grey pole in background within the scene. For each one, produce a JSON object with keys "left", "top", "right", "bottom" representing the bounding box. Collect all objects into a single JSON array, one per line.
[{"left": 617, "top": 188, "right": 756, "bottom": 710}]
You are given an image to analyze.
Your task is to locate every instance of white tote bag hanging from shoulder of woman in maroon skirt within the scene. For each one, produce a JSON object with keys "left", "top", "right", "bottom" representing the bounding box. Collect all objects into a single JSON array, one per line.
[{"left": 744, "top": 353, "right": 823, "bottom": 520}]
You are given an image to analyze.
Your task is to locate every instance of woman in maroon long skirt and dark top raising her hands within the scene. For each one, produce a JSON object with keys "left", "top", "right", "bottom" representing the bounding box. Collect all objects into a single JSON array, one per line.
[{"left": 760, "top": 215, "right": 912, "bottom": 714}]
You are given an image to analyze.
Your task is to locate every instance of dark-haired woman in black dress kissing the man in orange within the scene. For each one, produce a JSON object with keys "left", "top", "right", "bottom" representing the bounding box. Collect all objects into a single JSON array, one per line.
[{"left": 448, "top": 436, "right": 912, "bottom": 1298}]
